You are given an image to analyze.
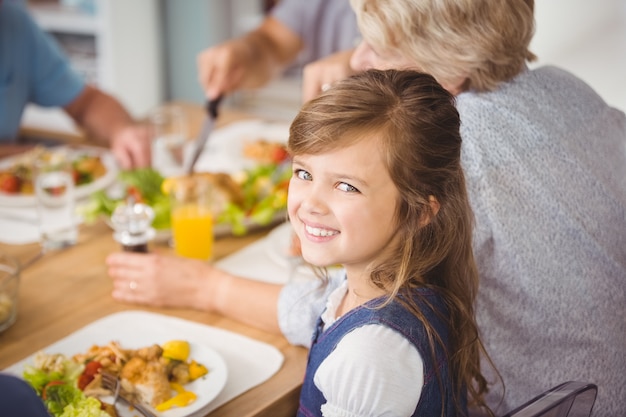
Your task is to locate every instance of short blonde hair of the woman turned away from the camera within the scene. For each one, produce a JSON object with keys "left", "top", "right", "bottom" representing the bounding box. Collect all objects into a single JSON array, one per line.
[{"left": 350, "top": 0, "right": 535, "bottom": 91}]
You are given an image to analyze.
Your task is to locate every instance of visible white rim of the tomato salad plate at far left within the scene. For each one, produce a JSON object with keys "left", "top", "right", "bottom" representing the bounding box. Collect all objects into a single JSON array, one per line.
[{"left": 0, "top": 147, "right": 118, "bottom": 207}]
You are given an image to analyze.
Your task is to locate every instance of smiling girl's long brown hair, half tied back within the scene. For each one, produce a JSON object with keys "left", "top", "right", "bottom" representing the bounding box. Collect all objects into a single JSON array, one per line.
[{"left": 288, "top": 70, "right": 498, "bottom": 414}]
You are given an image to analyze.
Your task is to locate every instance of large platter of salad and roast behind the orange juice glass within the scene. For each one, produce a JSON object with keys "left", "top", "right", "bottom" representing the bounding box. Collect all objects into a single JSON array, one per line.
[{"left": 78, "top": 150, "right": 291, "bottom": 238}]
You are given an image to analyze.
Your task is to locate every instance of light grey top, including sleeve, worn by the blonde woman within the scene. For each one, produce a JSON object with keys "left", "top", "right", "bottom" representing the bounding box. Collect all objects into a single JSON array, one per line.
[{"left": 279, "top": 67, "right": 626, "bottom": 417}]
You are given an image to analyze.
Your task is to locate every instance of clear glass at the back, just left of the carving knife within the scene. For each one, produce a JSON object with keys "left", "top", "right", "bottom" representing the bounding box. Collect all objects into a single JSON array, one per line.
[{"left": 148, "top": 104, "right": 189, "bottom": 177}]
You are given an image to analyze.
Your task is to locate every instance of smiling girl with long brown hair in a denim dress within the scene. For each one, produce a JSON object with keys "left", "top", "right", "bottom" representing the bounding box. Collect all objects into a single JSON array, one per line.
[{"left": 289, "top": 70, "right": 487, "bottom": 417}]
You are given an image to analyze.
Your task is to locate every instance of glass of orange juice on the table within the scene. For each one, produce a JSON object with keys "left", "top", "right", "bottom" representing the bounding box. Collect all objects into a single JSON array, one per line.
[{"left": 170, "top": 176, "right": 214, "bottom": 261}]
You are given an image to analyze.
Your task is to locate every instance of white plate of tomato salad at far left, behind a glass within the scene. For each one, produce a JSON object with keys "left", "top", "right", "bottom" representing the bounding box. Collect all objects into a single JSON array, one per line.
[{"left": 0, "top": 146, "right": 118, "bottom": 207}]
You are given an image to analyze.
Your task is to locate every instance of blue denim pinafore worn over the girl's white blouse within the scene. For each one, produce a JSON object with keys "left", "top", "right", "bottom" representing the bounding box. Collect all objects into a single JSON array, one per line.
[{"left": 298, "top": 289, "right": 467, "bottom": 417}]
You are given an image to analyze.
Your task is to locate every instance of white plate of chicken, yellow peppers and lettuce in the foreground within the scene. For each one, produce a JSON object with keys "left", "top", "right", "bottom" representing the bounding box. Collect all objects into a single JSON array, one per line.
[{"left": 7, "top": 316, "right": 228, "bottom": 417}]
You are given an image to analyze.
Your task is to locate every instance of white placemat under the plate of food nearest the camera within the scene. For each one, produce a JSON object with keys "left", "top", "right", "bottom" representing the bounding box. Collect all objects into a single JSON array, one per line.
[{"left": 5, "top": 311, "right": 284, "bottom": 417}]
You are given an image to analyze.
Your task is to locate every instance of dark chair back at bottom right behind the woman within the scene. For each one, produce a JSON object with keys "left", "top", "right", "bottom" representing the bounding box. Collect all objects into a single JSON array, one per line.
[{"left": 502, "top": 381, "right": 598, "bottom": 417}]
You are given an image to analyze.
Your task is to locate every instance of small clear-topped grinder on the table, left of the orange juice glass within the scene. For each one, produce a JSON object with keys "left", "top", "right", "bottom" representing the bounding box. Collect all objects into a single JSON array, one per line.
[{"left": 111, "top": 198, "right": 155, "bottom": 253}]
